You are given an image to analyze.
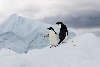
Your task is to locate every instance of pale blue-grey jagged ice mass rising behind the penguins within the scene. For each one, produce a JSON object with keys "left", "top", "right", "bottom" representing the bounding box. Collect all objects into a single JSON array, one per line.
[{"left": 0, "top": 14, "right": 75, "bottom": 53}]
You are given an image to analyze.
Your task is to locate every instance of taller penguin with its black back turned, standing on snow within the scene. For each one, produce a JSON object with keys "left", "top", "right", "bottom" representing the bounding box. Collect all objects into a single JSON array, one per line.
[{"left": 56, "top": 22, "right": 68, "bottom": 44}]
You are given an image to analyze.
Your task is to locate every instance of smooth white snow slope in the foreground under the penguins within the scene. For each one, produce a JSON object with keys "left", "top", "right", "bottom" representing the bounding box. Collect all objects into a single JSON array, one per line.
[{"left": 0, "top": 33, "right": 100, "bottom": 67}]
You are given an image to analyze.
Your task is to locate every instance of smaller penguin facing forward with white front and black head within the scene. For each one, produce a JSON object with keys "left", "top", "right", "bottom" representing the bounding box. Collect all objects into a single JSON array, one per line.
[{"left": 48, "top": 27, "right": 57, "bottom": 48}]
